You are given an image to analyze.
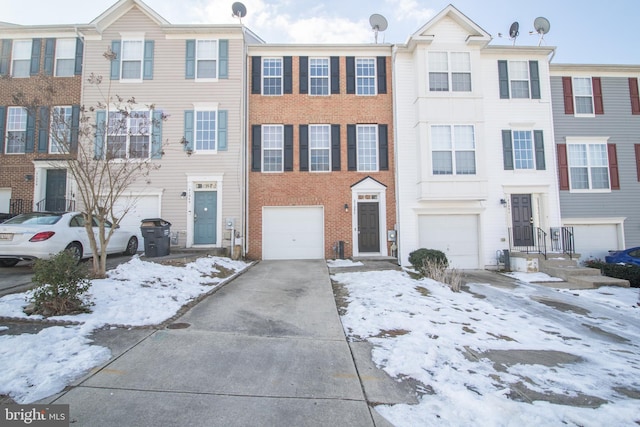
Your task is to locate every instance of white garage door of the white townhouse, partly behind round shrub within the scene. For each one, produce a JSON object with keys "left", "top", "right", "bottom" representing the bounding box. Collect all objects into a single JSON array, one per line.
[{"left": 418, "top": 215, "right": 479, "bottom": 269}]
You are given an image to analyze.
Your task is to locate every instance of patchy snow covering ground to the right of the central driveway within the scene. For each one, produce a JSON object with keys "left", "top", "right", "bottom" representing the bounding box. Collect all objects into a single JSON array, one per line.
[{"left": 332, "top": 271, "right": 640, "bottom": 427}]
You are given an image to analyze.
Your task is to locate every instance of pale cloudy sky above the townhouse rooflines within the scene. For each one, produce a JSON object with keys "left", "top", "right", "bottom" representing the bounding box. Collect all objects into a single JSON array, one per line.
[{"left": 0, "top": 0, "right": 640, "bottom": 65}]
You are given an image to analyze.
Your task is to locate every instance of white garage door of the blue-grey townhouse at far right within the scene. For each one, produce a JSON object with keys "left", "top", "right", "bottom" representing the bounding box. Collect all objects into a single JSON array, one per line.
[{"left": 568, "top": 224, "right": 624, "bottom": 261}]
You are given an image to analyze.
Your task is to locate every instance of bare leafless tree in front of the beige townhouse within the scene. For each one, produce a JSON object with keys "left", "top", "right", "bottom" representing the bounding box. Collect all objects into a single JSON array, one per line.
[{"left": 18, "top": 51, "right": 168, "bottom": 277}]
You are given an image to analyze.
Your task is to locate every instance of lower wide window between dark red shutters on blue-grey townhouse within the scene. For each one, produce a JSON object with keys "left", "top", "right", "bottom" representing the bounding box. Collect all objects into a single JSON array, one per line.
[{"left": 567, "top": 143, "right": 610, "bottom": 190}]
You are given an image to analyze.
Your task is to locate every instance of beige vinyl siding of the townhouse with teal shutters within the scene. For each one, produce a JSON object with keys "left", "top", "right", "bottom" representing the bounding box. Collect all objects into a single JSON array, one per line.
[{"left": 83, "top": 7, "right": 244, "bottom": 245}]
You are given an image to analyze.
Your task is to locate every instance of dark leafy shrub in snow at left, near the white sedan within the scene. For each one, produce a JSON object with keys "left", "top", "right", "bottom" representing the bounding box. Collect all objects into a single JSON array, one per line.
[{"left": 31, "top": 250, "right": 91, "bottom": 316}]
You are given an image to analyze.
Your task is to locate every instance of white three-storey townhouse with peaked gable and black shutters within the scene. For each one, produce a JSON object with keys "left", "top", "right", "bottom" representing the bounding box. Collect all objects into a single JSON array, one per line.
[{"left": 393, "top": 5, "right": 561, "bottom": 269}]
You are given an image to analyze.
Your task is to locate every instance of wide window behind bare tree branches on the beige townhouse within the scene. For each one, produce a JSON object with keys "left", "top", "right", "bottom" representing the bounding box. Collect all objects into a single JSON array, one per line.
[{"left": 107, "top": 111, "right": 152, "bottom": 159}]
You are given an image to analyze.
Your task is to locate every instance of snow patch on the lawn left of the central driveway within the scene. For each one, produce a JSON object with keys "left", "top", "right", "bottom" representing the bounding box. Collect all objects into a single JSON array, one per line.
[{"left": 0, "top": 257, "right": 249, "bottom": 403}]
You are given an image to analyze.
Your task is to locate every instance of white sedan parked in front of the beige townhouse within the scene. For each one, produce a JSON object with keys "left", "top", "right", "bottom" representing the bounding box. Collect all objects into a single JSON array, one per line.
[{"left": 0, "top": 212, "right": 138, "bottom": 267}]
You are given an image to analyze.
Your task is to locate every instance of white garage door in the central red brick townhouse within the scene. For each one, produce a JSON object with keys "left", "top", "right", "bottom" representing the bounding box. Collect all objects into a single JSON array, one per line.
[{"left": 262, "top": 206, "right": 324, "bottom": 259}]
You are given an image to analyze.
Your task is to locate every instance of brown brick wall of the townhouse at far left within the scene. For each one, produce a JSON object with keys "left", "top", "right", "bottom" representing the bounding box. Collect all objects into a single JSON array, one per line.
[{"left": 0, "top": 39, "right": 82, "bottom": 212}]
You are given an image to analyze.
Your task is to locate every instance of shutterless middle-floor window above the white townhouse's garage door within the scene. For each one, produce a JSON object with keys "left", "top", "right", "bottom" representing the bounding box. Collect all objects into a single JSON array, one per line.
[{"left": 431, "top": 125, "right": 476, "bottom": 175}]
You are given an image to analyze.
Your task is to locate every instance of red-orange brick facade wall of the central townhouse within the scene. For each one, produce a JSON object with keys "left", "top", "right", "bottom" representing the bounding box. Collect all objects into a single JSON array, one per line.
[{"left": 248, "top": 53, "right": 396, "bottom": 259}]
